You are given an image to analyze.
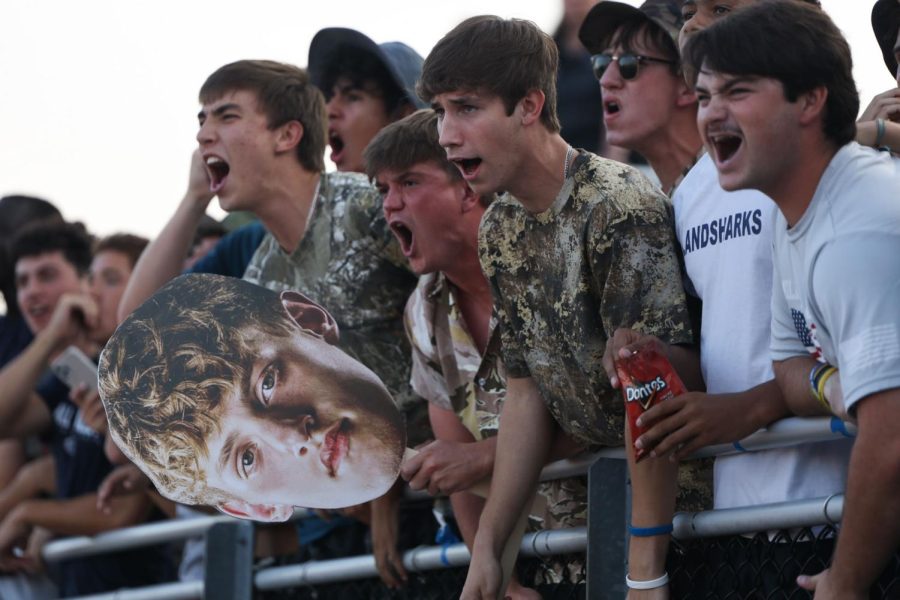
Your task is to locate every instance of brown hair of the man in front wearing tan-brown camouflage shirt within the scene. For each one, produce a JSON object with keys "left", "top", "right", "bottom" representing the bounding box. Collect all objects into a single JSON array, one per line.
[{"left": 416, "top": 15, "right": 559, "bottom": 133}]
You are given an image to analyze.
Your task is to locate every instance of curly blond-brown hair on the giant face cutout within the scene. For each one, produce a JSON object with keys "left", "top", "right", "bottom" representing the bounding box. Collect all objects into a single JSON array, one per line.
[{"left": 99, "top": 274, "right": 296, "bottom": 505}]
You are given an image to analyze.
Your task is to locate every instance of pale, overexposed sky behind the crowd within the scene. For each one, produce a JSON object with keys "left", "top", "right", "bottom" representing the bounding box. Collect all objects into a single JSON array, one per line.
[{"left": 0, "top": 0, "right": 892, "bottom": 236}]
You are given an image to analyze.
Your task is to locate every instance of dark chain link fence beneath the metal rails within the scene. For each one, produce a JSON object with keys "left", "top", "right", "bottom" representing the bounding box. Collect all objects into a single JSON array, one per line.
[{"left": 257, "top": 526, "right": 900, "bottom": 600}]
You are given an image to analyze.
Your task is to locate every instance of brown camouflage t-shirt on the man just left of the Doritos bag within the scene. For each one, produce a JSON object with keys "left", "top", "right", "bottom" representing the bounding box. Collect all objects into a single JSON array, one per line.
[{"left": 478, "top": 152, "right": 692, "bottom": 446}]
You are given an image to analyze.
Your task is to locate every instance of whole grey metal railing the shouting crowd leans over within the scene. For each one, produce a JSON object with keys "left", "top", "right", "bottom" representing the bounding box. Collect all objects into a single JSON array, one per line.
[{"left": 43, "top": 417, "right": 855, "bottom": 600}]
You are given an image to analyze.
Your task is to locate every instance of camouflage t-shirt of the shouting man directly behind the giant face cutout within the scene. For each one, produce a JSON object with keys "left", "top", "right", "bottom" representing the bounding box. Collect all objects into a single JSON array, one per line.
[{"left": 244, "top": 173, "right": 425, "bottom": 412}]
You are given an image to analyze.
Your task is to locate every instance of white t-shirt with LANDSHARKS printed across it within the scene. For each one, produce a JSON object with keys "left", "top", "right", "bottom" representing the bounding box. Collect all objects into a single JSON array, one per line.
[{"left": 672, "top": 156, "right": 852, "bottom": 508}]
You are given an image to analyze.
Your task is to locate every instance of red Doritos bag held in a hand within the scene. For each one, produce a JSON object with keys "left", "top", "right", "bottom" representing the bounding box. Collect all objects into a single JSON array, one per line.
[{"left": 616, "top": 346, "right": 687, "bottom": 461}]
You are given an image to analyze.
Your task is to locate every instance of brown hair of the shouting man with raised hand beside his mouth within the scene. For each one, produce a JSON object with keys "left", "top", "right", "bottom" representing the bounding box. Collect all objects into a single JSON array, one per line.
[{"left": 200, "top": 60, "right": 328, "bottom": 172}]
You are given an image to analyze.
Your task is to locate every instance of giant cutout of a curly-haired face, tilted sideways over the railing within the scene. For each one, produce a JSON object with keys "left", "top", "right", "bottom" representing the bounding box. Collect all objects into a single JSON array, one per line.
[{"left": 99, "top": 275, "right": 406, "bottom": 521}]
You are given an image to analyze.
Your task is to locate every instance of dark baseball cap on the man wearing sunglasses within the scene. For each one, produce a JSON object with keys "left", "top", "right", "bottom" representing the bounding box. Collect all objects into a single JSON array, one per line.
[{"left": 578, "top": 0, "right": 684, "bottom": 54}]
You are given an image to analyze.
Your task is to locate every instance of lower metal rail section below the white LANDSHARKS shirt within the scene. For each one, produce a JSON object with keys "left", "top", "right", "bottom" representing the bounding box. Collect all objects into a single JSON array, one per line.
[{"left": 672, "top": 494, "right": 844, "bottom": 539}]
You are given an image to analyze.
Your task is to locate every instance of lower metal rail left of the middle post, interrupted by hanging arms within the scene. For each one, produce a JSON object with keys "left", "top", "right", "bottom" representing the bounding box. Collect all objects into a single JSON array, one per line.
[{"left": 254, "top": 527, "right": 587, "bottom": 590}]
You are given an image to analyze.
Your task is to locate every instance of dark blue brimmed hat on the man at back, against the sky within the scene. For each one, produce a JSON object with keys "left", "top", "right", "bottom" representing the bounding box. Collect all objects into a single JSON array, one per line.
[{"left": 308, "top": 27, "right": 426, "bottom": 108}]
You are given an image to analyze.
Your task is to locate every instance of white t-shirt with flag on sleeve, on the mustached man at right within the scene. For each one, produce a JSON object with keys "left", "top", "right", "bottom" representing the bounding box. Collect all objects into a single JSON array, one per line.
[{"left": 771, "top": 143, "right": 900, "bottom": 409}]
